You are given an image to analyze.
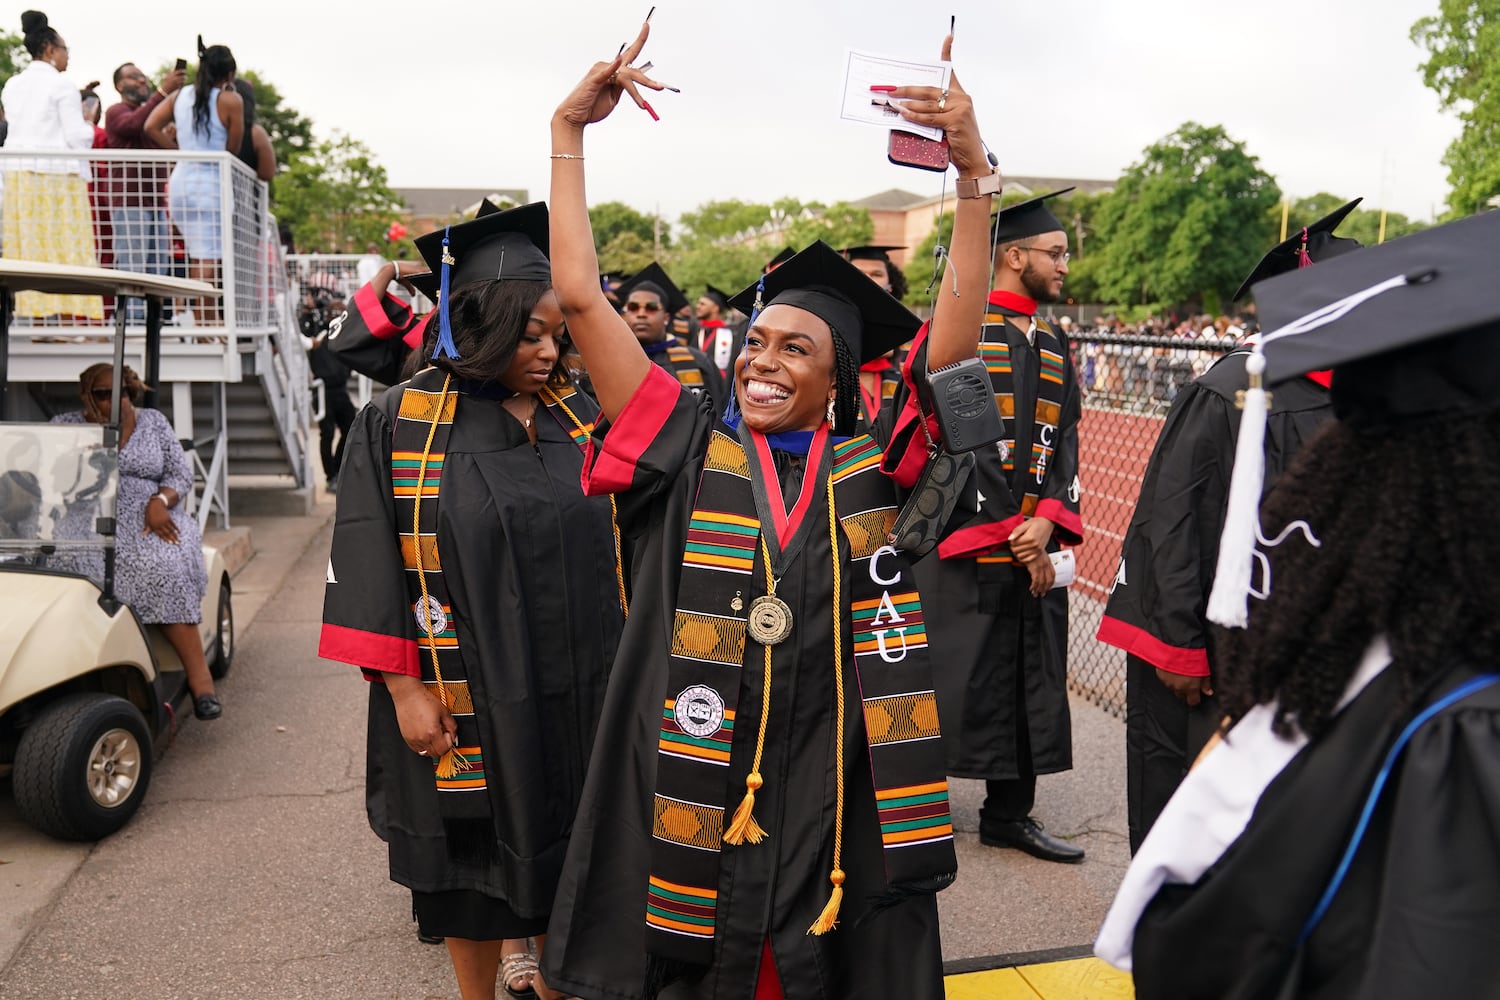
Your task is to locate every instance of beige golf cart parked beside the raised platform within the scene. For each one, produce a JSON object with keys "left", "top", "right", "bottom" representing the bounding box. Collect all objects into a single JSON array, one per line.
[{"left": 0, "top": 259, "right": 234, "bottom": 841}]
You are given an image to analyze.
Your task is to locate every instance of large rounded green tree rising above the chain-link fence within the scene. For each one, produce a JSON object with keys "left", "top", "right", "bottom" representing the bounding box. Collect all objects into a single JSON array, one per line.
[{"left": 1089, "top": 121, "right": 1281, "bottom": 312}]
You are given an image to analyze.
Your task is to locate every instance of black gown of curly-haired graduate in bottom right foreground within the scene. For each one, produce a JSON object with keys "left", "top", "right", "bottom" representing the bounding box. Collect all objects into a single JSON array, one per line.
[{"left": 1131, "top": 654, "right": 1500, "bottom": 1000}]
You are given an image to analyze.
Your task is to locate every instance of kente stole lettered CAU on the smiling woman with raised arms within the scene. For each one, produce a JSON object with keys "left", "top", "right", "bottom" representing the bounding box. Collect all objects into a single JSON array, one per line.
[{"left": 645, "top": 424, "right": 957, "bottom": 966}]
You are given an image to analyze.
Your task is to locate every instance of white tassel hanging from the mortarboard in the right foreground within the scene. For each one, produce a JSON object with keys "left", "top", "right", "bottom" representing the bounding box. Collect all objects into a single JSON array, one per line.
[{"left": 1208, "top": 348, "right": 1271, "bottom": 628}]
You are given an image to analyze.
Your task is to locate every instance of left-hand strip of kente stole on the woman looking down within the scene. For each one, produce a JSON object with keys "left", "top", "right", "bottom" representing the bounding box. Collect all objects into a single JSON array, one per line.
[{"left": 390, "top": 370, "right": 492, "bottom": 856}]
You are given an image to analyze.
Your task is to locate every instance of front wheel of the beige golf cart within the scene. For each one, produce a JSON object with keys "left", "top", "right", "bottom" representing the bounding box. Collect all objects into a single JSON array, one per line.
[{"left": 11, "top": 693, "right": 152, "bottom": 841}]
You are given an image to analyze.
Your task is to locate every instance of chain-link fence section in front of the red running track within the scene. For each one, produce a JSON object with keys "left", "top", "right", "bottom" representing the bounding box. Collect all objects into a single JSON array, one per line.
[{"left": 1068, "top": 333, "right": 1235, "bottom": 718}]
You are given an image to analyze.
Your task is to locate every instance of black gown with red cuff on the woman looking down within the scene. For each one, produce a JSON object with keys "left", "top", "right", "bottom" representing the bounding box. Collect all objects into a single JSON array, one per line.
[{"left": 320, "top": 385, "right": 621, "bottom": 916}]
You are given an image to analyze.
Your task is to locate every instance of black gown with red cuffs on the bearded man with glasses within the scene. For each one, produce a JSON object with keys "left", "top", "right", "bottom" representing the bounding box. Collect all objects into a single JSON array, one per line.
[{"left": 917, "top": 304, "right": 1083, "bottom": 780}]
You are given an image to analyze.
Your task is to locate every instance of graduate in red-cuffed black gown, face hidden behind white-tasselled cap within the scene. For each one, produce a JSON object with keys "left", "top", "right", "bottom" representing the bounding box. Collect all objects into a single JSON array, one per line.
[{"left": 1098, "top": 198, "right": 1359, "bottom": 852}]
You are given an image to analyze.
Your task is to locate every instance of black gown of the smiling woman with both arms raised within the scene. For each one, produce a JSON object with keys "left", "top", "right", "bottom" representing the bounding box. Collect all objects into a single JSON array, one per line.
[{"left": 543, "top": 370, "right": 944, "bottom": 1000}]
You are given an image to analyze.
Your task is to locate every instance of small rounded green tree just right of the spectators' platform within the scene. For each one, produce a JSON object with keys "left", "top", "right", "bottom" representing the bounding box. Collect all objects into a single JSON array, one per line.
[{"left": 276, "top": 132, "right": 404, "bottom": 253}]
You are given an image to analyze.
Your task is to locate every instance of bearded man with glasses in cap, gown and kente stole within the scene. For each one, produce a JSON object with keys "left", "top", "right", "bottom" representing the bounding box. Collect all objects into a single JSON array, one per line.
[{"left": 918, "top": 189, "right": 1083, "bottom": 862}]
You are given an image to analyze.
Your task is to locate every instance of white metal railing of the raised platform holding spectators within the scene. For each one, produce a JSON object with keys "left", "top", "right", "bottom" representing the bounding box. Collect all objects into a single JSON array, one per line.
[{"left": 0, "top": 148, "right": 312, "bottom": 491}]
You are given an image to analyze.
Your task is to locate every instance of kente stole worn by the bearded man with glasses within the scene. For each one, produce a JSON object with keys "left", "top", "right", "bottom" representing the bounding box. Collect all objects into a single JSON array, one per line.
[{"left": 980, "top": 310, "right": 1067, "bottom": 562}]
